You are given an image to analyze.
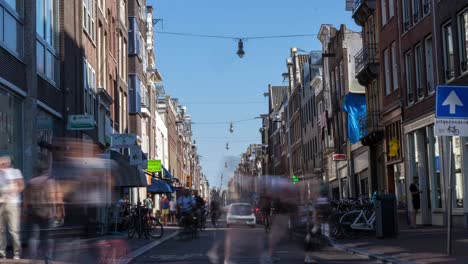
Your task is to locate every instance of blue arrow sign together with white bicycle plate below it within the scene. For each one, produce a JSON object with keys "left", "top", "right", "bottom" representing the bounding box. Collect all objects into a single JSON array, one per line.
[{"left": 434, "top": 86, "right": 468, "bottom": 137}]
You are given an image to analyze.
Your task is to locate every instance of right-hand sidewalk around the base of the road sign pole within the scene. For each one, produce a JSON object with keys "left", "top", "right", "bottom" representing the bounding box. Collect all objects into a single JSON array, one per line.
[{"left": 335, "top": 226, "right": 468, "bottom": 263}]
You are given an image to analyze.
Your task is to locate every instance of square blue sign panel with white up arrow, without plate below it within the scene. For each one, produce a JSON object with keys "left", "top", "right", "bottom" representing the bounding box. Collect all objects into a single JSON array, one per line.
[{"left": 436, "top": 86, "right": 468, "bottom": 119}]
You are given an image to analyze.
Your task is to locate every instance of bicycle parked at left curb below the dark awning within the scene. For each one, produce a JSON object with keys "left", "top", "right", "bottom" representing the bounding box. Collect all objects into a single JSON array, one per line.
[{"left": 127, "top": 206, "right": 164, "bottom": 239}]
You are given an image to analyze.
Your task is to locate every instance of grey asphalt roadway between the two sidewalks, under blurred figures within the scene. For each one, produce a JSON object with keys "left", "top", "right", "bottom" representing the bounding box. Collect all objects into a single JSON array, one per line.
[{"left": 130, "top": 222, "right": 375, "bottom": 264}]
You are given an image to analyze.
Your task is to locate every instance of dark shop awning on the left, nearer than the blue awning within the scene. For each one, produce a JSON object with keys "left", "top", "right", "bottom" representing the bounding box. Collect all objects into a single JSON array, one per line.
[{"left": 111, "top": 151, "right": 148, "bottom": 187}]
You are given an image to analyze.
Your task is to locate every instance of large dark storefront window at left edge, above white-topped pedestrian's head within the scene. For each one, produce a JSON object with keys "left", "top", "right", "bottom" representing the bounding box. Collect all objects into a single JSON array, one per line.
[{"left": 0, "top": 90, "right": 23, "bottom": 169}]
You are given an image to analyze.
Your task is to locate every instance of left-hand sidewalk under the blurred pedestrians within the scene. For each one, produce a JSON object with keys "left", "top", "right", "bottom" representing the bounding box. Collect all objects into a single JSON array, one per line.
[{"left": 0, "top": 227, "right": 179, "bottom": 264}]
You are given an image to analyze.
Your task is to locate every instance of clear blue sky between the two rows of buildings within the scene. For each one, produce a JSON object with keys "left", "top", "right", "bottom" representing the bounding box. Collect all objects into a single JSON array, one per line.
[{"left": 148, "top": 0, "right": 360, "bottom": 186}]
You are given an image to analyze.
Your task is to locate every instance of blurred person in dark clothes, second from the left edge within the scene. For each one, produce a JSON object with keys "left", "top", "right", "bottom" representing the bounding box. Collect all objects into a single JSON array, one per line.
[{"left": 23, "top": 154, "right": 57, "bottom": 263}]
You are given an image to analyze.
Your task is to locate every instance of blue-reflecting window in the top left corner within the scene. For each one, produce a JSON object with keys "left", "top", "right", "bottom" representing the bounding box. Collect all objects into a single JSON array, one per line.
[{"left": 0, "top": 0, "right": 24, "bottom": 57}]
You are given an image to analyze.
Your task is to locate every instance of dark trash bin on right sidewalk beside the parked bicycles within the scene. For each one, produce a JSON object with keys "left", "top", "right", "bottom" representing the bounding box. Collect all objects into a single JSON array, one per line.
[{"left": 375, "top": 194, "right": 398, "bottom": 238}]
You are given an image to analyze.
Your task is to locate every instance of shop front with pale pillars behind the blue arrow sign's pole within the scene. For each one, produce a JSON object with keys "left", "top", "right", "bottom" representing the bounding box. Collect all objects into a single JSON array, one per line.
[{"left": 404, "top": 115, "right": 468, "bottom": 226}]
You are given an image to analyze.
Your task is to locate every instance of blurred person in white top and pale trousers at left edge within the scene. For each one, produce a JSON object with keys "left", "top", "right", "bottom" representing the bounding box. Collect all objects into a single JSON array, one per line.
[{"left": 0, "top": 156, "right": 24, "bottom": 259}]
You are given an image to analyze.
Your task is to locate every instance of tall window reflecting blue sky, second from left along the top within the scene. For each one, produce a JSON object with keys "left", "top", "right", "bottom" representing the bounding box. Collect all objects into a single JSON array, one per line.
[{"left": 36, "top": 0, "right": 60, "bottom": 86}]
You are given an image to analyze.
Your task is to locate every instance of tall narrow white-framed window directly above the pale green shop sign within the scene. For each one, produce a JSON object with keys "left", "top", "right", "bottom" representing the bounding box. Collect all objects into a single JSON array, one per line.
[{"left": 83, "top": 58, "right": 96, "bottom": 116}]
